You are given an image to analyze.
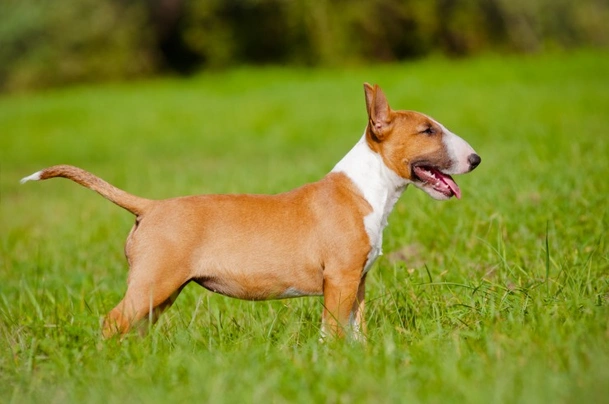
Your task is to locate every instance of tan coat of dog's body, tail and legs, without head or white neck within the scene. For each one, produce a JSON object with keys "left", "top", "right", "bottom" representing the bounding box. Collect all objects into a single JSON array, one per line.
[{"left": 34, "top": 165, "right": 370, "bottom": 337}]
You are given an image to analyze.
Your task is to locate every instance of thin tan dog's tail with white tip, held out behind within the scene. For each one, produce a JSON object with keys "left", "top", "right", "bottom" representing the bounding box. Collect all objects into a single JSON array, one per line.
[{"left": 21, "top": 165, "right": 153, "bottom": 216}]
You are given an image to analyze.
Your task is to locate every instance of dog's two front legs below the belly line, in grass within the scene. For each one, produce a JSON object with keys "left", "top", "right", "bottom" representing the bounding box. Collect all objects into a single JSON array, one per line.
[{"left": 321, "top": 272, "right": 364, "bottom": 339}]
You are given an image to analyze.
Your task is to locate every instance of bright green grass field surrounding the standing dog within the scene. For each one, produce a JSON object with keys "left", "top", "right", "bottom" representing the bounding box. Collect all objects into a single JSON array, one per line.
[{"left": 0, "top": 51, "right": 609, "bottom": 404}]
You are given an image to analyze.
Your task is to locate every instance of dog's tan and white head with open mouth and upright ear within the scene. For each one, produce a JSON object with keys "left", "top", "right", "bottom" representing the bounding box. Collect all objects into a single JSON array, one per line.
[{"left": 364, "top": 83, "right": 480, "bottom": 200}]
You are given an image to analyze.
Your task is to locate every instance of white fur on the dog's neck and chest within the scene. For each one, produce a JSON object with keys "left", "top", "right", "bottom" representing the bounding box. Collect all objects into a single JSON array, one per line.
[{"left": 332, "top": 133, "right": 409, "bottom": 273}]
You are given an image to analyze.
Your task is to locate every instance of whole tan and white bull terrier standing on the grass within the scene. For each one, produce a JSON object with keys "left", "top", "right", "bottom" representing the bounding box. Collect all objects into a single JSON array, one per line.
[{"left": 21, "top": 84, "right": 480, "bottom": 337}]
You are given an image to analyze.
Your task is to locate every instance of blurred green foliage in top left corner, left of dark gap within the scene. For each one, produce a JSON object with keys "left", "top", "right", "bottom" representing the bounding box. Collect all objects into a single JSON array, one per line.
[{"left": 0, "top": 0, "right": 155, "bottom": 90}]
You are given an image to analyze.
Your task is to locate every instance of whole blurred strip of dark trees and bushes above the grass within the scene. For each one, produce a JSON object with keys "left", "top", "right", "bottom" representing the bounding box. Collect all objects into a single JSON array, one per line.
[{"left": 0, "top": 0, "right": 609, "bottom": 92}]
